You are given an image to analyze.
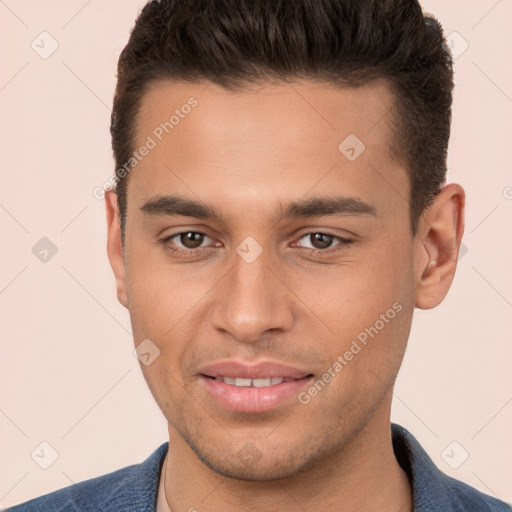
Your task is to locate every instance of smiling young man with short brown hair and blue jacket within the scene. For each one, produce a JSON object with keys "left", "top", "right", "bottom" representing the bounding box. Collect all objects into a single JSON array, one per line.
[{"left": 7, "top": 0, "right": 511, "bottom": 512}]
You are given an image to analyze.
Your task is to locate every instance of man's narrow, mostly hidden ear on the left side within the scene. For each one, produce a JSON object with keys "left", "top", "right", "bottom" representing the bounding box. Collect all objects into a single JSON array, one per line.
[{"left": 105, "top": 190, "right": 128, "bottom": 308}]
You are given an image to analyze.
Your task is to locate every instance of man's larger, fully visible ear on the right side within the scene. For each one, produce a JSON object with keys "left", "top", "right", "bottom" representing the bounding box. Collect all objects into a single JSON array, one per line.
[{"left": 415, "top": 183, "right": 465, "bottom": 309}]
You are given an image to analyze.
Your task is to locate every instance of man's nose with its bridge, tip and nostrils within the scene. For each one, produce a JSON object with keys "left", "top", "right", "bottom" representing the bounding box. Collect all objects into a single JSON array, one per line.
[{"left": 211, "top": 245, "right": 294, "bottom": 343}]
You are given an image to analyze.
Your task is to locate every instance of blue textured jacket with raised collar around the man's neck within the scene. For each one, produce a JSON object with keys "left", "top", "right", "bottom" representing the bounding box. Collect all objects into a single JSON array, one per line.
[{"left": 7, "top": 424, "right": 512, "bottom": 512}]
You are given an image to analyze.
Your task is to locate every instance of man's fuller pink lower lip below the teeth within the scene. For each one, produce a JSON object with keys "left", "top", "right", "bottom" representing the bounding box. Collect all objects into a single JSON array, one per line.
[{"left": 200, "top": 375, "right": 312, "bottom": 412}]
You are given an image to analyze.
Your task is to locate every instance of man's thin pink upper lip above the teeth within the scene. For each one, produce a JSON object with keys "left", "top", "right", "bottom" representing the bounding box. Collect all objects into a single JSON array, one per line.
[{"left": 198, "top": 361, "right": 311, "bottom": 379}]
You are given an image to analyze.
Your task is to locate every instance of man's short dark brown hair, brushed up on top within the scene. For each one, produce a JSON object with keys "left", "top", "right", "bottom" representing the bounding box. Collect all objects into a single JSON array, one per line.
[{"left": 110, "top": 0, "right": 453, "bottom": 244}]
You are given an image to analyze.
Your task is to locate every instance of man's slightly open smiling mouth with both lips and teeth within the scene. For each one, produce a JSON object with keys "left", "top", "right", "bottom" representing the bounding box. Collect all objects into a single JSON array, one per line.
[{"left": 198, "top": 361, "right": 313, "bottom": 413}]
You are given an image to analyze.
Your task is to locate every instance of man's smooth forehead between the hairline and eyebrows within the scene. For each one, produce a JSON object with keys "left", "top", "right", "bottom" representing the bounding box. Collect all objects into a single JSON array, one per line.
[{"left": 128, "top": 80, "right": 408, "bottom": 220}]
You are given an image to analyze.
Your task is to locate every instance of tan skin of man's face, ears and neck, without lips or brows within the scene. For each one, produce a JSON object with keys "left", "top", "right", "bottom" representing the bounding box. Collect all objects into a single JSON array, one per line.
[{"left": 106, "top": 80, "right": 464, "bottom": 512}]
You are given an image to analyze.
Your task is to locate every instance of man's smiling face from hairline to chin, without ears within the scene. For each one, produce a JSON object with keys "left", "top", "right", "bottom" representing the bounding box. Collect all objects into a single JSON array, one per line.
[{"left": 115, "top": 81, "right": 415, "bottom": 480}]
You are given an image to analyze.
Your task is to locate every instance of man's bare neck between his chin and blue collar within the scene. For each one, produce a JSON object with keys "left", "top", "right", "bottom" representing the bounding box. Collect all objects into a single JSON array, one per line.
[{"left": 164, "top": 404, "right": 412, "bottom": 512}]
